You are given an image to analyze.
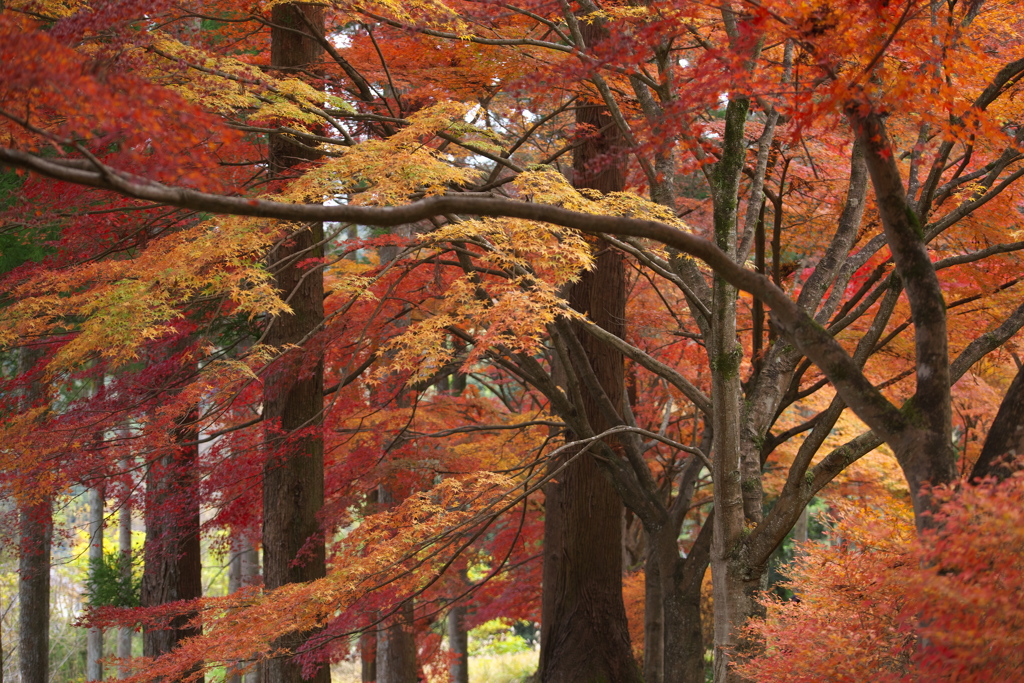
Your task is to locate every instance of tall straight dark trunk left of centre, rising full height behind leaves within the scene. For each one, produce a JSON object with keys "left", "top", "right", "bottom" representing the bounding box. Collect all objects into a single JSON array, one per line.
[{"left": 263, "top": 3, "right": 331, "bottom": 683}]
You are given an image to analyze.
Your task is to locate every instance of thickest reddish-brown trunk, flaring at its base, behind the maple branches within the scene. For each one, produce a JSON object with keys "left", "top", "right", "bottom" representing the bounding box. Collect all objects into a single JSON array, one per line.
[{"left": 541, "top": 18, "right": 641, "bottom": 683}]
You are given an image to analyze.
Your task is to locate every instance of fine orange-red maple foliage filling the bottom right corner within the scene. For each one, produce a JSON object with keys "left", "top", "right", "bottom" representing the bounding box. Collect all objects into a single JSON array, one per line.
[{"left": 742, "top": 475, "right": 1024, "bottom": 683}]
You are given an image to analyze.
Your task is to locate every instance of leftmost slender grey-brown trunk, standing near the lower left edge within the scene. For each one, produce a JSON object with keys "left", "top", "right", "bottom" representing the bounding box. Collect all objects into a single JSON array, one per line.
[{"left": 17, "top": 497, "right": 51, "bottom": 683}]
